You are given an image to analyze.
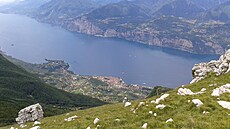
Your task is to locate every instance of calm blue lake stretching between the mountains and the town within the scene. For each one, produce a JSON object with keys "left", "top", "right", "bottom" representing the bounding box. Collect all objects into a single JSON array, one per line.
[{"left": 0, "top": 14, "right": 217, "bottom": 88}]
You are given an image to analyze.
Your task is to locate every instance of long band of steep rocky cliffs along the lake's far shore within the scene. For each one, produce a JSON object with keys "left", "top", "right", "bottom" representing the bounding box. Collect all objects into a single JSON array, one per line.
[{"left": 58, "top": 16, "right": 224, "bottom": 54}]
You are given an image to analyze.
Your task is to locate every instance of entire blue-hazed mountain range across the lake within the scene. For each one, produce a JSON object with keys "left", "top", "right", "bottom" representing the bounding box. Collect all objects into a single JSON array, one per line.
[{"left": 3, "top": 0, "right": 230, "bottom": 54}]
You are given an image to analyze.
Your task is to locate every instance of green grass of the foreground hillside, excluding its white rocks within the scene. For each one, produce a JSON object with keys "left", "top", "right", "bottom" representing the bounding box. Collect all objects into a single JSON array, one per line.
[{"left": 3, "top": 74, "right": 230, "bottom": 129}]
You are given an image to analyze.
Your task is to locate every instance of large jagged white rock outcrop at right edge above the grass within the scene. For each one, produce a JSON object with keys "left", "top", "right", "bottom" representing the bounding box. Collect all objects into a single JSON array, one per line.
[{"left": 190, "top": 49, "right": 230, "bottom": 84}]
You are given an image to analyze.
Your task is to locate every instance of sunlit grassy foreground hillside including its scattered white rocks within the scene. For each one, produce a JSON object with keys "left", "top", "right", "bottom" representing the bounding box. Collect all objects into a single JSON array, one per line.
[{"left": 3, "top": 51, "right": 230, "bottom": 129}]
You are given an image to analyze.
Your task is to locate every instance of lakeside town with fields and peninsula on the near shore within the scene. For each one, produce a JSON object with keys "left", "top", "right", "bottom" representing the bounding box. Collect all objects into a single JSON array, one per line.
[{"left": 6, "top": 56, "right": 152, "bottom": 103}]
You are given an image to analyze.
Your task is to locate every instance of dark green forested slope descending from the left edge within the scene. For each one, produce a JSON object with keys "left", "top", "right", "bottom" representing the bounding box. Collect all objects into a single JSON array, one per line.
[{"left": 0, "top": 55, "right": 105, "bottom": 126}]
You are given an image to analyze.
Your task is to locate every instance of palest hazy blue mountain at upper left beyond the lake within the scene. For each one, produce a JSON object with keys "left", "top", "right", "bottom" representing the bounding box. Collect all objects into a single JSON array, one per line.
[{"left": 34, "top": 0, "right": 100, "bottom": 24}]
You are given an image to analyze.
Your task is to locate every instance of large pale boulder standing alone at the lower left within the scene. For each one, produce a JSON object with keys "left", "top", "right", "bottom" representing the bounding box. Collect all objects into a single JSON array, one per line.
[{"left": 16, "top": 103, "right": 44, "bottom": 125}]
